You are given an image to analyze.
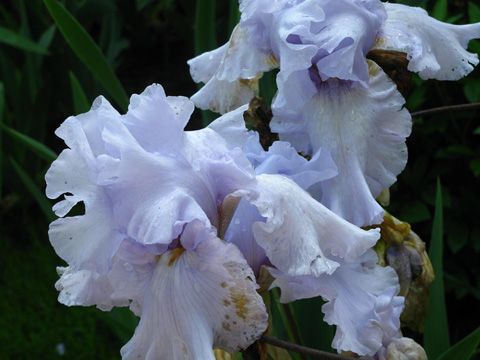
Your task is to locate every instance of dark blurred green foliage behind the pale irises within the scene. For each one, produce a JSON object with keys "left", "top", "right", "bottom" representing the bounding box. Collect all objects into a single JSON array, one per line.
[{"left": 0, "top": 0, "right": 480, "bottom": 360}]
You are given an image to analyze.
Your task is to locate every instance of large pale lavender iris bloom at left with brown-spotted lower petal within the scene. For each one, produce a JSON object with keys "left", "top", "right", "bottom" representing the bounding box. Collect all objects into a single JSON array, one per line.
[{"left": 46, "top": 85, "right": 267, "bottom": 359}]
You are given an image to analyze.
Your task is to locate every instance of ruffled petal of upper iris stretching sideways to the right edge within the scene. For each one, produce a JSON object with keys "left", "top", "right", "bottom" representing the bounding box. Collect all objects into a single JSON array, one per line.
[{"left": 375, "top": 3, "right": 480, "bottom": 80}]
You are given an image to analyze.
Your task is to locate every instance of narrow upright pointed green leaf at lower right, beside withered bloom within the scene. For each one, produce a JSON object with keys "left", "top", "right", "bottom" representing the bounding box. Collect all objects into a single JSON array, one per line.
[{"left": 424, "top": 180, "right": 450, "bottom": 359}]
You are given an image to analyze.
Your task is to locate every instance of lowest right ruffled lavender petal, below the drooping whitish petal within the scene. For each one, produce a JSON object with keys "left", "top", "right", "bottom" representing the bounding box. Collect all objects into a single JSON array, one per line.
[{"left": 270, "top": 250, "right": 404, "bottom": 355}]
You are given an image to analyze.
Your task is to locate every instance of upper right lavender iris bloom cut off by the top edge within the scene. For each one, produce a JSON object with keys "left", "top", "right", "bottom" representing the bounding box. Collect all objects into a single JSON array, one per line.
[{"left": 189, "top": 0, "right": 480, "bottom": 226}]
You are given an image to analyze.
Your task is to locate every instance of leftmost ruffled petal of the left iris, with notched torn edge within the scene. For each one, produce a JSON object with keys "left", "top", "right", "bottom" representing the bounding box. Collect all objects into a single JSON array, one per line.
[{"left": 45, "top": 98, "right": 123, "bottom": 276}]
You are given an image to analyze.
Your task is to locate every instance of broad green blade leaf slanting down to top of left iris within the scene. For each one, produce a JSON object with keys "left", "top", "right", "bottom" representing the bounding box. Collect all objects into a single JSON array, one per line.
[{"left": 44, "top": 0, "right": 128, "bottom": 111}]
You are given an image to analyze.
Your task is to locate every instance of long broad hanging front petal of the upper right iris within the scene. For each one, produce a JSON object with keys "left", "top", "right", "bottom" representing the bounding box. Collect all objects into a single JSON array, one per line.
[{"left": 272, "top": 62, "right": 411, "bottom": 226}]
